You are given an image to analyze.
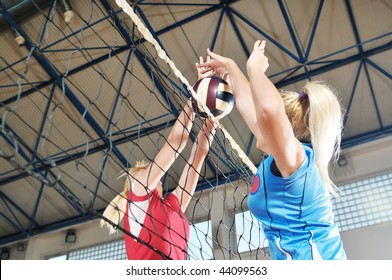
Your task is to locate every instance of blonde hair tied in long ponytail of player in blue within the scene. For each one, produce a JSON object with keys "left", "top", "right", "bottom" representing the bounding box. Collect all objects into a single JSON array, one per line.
[{"left": 282, "top": 81, "right": 343, "bottom": 194}]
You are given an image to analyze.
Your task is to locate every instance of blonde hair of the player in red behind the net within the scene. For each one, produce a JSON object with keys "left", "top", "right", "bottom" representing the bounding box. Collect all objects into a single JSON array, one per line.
[{"left": 101, "top": 161, "right": 148, "bottom": 234}]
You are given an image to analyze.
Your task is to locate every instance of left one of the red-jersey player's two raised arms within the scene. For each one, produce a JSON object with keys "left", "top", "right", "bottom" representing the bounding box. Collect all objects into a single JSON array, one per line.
[{"left": 133, "top": 102, "right": 195, "bottom": 196}]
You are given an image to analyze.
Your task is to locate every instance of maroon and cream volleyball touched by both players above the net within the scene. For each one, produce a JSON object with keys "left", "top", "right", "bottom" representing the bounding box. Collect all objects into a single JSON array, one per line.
[{"left": 192, "top": 76, "right": 234, "bottom": 120}]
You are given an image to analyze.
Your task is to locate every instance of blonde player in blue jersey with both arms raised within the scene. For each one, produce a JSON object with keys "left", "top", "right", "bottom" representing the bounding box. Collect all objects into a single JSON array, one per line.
[{"left": 200, "top": 41, "right": 346, "bottom": 260}]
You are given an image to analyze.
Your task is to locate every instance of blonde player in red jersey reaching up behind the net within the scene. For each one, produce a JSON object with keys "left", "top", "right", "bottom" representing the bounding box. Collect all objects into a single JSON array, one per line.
[{"left": 101, "top": 58, "right": 215, "bottom": 260}]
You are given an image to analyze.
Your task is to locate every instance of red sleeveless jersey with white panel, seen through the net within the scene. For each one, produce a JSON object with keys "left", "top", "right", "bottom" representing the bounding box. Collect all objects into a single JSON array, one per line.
[{"left": 124, "top": 189, "right": 189, "bottom": 260}]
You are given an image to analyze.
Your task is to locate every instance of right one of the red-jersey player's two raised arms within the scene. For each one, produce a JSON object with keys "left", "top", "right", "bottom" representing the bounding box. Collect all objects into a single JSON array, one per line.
[{"left": 174, "top": 116, "right": 215, "bottom": 212}]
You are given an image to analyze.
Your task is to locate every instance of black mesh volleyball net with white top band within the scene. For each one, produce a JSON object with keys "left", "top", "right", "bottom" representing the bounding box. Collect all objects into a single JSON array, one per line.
[{"left": 0, "top": 0, "right": 268, "bottom": 259}]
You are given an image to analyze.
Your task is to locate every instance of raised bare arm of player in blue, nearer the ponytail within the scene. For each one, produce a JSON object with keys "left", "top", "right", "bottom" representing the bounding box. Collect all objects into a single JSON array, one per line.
[{"left": 247, "top": 41, "right": 305, "bottom": 177}]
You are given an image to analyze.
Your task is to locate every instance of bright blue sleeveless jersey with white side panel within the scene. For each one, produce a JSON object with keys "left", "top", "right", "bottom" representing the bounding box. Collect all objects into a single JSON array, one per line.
[{"left": 248, "top": 145, "right": 346, "bottom": 260}]
